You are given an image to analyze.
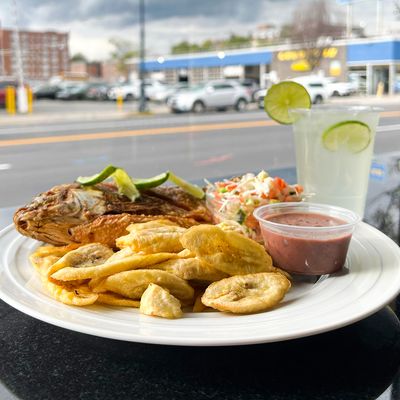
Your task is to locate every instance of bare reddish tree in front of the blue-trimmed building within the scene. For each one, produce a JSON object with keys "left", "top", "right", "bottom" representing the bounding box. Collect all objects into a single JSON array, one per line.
[{"left": 285, "top": 0, "right": 344, "bottom": 71}]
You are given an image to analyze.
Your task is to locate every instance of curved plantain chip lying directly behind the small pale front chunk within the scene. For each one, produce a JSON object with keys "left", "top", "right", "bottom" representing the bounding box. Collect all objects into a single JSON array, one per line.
[{"left": 102, "top": 269, "right": 194, "bottom": 302}]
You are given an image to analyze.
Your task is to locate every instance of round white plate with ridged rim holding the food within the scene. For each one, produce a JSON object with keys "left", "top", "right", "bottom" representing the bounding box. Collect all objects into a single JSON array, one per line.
[{"left": 0, "top": 223, "right": 400, "bottom": 346}]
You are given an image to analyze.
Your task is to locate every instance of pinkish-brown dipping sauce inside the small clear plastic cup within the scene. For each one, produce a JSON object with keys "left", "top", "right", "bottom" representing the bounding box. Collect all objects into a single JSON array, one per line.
[{"left": 260, "top": 212, "right": 352, "bottom": 275}]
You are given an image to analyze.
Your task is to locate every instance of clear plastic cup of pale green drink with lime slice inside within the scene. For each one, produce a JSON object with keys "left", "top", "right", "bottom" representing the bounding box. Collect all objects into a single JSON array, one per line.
[{"left": 290, "top": 106, "right": 381, "bottom": 217}]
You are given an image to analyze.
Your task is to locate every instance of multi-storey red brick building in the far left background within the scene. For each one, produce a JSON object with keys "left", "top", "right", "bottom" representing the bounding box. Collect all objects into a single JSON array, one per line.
[{"left": 0, "top": 29, "right": 69, "bottom": 81}]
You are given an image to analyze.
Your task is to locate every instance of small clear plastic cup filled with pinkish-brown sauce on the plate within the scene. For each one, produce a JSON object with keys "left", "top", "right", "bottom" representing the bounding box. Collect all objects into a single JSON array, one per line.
[{"left": 254, "top": 202, "right": 360, "bottom": 275}]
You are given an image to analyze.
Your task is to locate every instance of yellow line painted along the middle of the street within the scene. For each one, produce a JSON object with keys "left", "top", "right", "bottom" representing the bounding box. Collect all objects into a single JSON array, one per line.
[{"left": 0, "top": 111, "right": 400, "bottom": 147}]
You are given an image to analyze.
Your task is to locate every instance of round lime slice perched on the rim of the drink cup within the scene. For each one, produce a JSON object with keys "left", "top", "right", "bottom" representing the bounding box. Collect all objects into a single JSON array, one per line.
[{"left": 264, "top": 81, "right": 311, "bottom": 125}]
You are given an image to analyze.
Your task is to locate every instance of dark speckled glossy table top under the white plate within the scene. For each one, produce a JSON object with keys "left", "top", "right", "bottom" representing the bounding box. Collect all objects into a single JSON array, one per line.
[{"left": 0, "top": 154, "right": 400, "bottom": 400}]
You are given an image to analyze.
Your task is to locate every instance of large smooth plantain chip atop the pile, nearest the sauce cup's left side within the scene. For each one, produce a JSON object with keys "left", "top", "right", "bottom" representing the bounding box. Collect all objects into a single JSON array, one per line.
[{"left": 181, "top": 225, "right": 274, "bottom": 275}]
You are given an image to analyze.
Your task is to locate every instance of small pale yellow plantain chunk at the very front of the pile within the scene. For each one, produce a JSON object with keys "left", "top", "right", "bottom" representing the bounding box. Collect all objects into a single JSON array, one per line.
[{"left": 140, "top": 283, "right": 183, "bottom": 319}]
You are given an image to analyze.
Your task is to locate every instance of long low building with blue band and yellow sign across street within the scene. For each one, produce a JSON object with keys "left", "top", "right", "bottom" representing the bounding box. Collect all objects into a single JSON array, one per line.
[{"left": 132, "top": 37, "right": 400, "bottom": 94}]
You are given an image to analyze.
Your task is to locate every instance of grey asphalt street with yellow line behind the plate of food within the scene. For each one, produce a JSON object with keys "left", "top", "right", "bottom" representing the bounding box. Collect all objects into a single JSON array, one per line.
[{"left": 0, "top": 98, "right": 400, "bottom": 207}]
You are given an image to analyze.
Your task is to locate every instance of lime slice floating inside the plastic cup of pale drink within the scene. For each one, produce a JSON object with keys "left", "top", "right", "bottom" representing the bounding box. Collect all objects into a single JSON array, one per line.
[{"left": 322, "top": 121, "right": 371, "bottom": 153}]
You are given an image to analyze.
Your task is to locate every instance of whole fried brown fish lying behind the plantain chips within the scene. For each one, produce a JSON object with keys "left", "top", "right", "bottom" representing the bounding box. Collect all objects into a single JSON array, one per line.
[{"left": 14, "top": 183, "right": 212, "bottom": 247}]
